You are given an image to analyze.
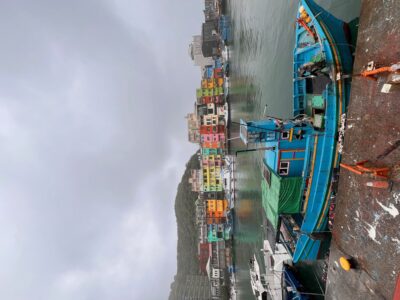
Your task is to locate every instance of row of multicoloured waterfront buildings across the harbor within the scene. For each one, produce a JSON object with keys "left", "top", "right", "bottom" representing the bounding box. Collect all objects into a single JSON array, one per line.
[{"left": 177, "top": 0, "right": 232, "bottom": 299}]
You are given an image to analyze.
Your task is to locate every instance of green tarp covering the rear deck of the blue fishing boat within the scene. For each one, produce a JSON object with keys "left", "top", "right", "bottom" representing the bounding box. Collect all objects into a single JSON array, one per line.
[{"left": 261, "top": 168, "right": 302, "bottom": 229}]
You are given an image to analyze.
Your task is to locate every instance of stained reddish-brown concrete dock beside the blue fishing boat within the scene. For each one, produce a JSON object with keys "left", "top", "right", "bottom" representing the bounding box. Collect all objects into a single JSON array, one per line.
[{"left": 326, "top": 0, "right": 400, "bottom": 300}]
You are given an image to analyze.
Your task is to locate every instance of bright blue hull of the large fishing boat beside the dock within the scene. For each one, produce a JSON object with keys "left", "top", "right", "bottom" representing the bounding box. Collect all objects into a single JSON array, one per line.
[{"left": 293, "top": 0, "right": 353, "bottom": 263}]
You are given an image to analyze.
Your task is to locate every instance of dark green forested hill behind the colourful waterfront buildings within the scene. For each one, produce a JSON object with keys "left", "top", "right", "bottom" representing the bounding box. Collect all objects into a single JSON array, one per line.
[{"left": 169, "top": 153, "right": 200, "bottom": 300}]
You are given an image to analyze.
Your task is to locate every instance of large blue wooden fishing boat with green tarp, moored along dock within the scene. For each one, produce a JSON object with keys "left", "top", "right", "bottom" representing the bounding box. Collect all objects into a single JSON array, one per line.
[{"left": 240, "top": 0, "right": 353, "bottom": 263}]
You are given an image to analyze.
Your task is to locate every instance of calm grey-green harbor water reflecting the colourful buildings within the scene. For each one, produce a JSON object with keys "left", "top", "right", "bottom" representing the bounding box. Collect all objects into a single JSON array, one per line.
[{"left": 227, "top": 0, "right": 361, "bottom": 299}]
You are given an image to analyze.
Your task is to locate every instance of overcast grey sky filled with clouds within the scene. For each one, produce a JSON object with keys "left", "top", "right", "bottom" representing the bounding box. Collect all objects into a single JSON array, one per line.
[{"left": 0, "top": 0, "right": 203, "bottom": 300}]
